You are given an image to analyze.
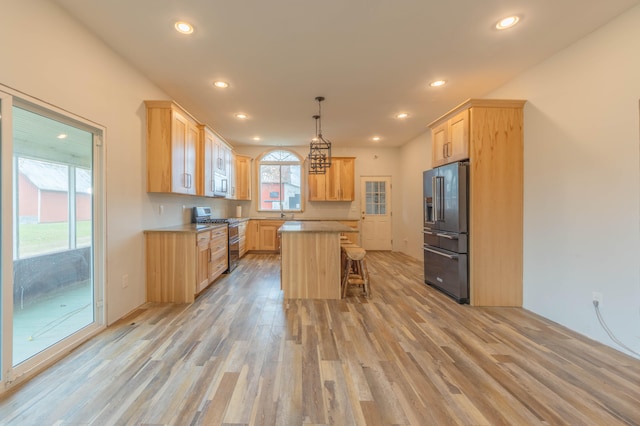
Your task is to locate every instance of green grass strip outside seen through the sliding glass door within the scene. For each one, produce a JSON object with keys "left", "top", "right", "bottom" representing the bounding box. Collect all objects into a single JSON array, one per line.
[{"left": 18, "top": 220, "right": 91, "bottom": 258}]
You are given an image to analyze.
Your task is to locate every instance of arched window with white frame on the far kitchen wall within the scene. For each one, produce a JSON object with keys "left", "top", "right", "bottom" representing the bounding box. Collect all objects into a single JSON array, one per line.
[{"left": 258, "top": 149, "right": 302, "bottom": 212}]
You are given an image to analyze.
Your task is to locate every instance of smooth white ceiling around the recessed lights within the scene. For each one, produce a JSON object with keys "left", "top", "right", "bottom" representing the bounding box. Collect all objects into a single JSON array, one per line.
[{"left": 52, "top": 0, "right": 640, "bottom": 147}]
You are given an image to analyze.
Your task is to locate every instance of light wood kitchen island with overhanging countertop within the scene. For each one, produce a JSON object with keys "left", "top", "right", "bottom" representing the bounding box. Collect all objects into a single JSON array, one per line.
[{"left": 278, "top": 221, "right": 358, "bottom": 299}]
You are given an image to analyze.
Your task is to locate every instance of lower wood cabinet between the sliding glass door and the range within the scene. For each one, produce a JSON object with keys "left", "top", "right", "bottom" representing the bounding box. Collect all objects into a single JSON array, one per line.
[{"left": 145, "top": 225, "right": 228, "bottom": 303}]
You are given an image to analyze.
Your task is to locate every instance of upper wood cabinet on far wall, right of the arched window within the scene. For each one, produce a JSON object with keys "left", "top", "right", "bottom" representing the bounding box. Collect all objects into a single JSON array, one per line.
[{"left": 307, "top": 157, "right": 355, "bottom": 201}]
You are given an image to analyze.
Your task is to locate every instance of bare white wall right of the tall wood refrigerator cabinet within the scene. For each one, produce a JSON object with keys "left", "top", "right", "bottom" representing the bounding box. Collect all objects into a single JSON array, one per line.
[{"left": 490, "top": 6, "right": 640, "bottom": 358}]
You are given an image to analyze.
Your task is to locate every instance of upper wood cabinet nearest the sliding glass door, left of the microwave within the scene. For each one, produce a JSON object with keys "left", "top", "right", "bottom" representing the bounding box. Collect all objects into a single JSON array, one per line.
[{"left": 145, "top": 101, "right": 200, "bottom": 195}]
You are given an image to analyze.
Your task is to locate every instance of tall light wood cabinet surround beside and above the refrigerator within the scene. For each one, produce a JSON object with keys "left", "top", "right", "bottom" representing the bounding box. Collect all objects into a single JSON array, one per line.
[{"left": 429, "top": 99, "right": 525, "bottom": 306}]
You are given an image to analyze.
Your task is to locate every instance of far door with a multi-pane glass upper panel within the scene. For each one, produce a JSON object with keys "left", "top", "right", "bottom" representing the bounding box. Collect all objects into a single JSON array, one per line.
[{"left": 360, "top": 176, "right": 392, "bottom": 250}]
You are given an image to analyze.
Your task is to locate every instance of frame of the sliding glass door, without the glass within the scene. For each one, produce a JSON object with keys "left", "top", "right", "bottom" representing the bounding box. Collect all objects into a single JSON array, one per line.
[{"left": 0, "top": 85, "right": 106, "bottom": 395}]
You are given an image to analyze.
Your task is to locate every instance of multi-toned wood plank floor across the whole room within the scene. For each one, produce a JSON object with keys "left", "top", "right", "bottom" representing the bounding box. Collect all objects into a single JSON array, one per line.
[{"left": 0, "top": 252, "right": 640, "bottom": 425}]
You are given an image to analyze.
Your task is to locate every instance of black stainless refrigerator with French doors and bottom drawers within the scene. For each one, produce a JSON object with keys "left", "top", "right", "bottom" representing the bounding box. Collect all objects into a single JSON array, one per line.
[{"left": 423, "top": 162, "right": 469, "bottom": 303}]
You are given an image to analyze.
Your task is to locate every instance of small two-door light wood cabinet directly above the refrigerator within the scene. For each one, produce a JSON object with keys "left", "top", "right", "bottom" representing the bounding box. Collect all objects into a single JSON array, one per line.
[{"left": 431, "top": 110, "right": 469, "bottom": 167}]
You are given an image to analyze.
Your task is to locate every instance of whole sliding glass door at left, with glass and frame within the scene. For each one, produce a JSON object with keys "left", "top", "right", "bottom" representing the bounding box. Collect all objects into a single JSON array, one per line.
[{"left": 0, "top": 88, "right": 104, "bottom": 392}]
